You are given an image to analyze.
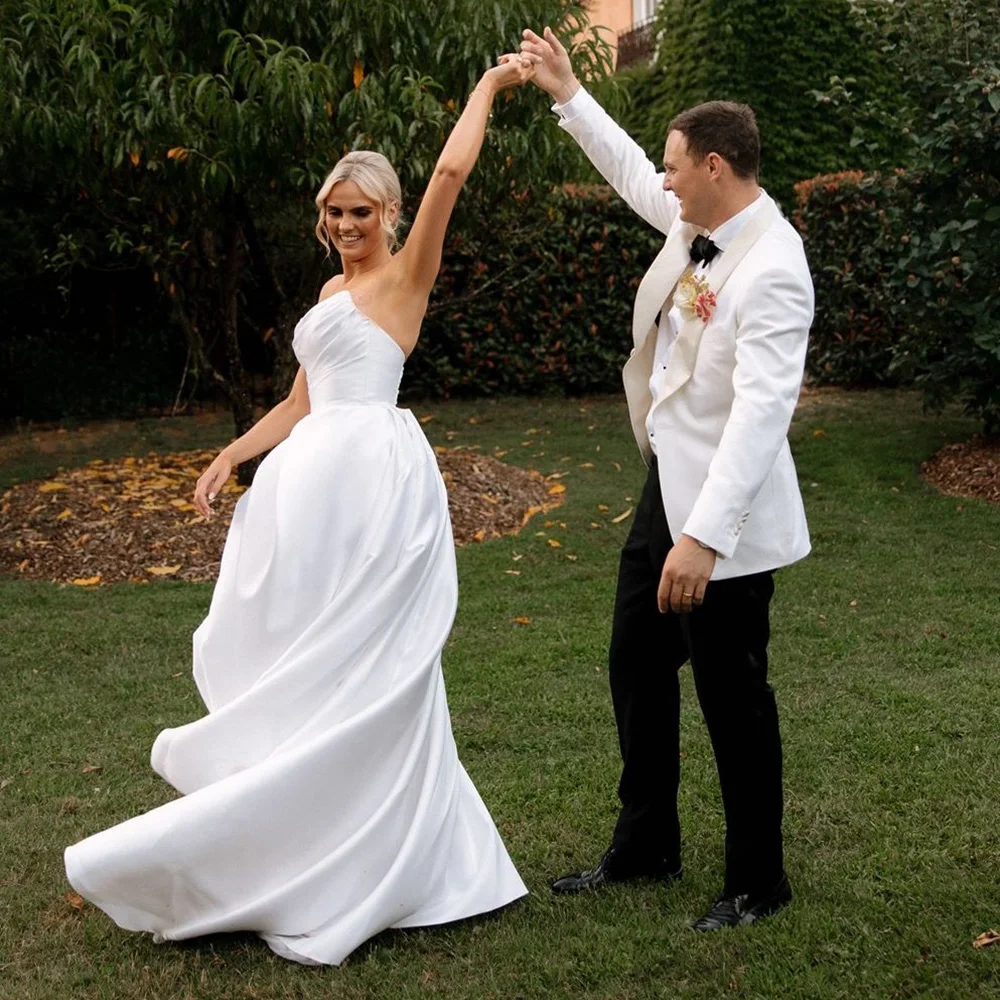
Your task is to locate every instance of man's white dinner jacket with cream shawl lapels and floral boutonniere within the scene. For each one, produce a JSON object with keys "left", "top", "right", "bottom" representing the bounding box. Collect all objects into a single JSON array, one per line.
[{"left": 555, "top": 88, "right": 813, "bottom": 580}]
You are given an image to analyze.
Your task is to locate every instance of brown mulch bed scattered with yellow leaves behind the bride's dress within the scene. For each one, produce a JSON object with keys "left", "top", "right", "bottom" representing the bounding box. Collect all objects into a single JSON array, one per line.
[{"left": 0, "top": 447, "right": 565, "bottom": 587}]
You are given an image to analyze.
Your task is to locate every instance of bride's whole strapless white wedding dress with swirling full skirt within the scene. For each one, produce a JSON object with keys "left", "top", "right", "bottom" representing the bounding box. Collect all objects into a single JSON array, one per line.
[{"left": 66, "top": 290, "right": 527, "bottom": 964}]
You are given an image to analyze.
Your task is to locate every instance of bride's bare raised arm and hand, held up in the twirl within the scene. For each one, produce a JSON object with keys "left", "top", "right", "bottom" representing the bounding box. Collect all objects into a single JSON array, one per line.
[{"left": 396, "top": 55, "right": 534, "bottom": 295}]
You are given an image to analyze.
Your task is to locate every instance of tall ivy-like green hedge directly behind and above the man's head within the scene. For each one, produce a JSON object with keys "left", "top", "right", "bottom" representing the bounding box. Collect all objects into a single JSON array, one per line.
[{"left": 618, "top": 0, "right": 898, "bottom": 207}]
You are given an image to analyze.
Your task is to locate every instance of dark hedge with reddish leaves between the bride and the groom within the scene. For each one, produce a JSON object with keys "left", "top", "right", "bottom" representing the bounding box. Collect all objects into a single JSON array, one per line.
[{"left": 404, "top": 186, "right": 663, "bottom": 397}]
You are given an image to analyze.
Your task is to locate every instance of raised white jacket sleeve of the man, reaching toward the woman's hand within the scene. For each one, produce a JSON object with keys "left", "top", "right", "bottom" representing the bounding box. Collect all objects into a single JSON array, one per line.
[{"left": 552, "top": 87, "right": 679, "bottom": 234}]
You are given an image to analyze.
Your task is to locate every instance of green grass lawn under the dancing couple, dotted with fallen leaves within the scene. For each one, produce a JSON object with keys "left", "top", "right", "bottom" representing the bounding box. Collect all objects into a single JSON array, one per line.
[{"left": 0, "top": 393, "right": 1000, "bottom": 1000}]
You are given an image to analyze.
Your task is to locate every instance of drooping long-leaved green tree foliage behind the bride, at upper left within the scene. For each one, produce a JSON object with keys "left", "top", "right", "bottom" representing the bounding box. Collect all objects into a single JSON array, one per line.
[{"left": 0, "top": 0, "right": 609, "bottom": 472}]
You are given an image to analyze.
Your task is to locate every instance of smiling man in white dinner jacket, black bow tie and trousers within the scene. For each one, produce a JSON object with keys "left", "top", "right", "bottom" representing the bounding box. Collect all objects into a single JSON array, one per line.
[{"left": 521, "top": 28, "right": 813, "bottom": 931}]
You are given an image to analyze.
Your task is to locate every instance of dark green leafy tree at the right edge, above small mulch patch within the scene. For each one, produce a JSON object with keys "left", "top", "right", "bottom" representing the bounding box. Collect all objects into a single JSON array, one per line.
[{"left": 818, "top": 0, "right": 1000, "bottom": 431}]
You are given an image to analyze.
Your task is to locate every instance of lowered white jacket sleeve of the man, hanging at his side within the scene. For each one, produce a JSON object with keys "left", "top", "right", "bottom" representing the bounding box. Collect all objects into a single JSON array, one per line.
[{"left": 684, "top": 258, "right": 813, "bottom": 559}]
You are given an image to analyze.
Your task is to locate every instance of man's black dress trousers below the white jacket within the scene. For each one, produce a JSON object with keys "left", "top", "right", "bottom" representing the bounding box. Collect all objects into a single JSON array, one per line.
[{"left": 609, "top": 459, "right": 783, "bottom": 893}]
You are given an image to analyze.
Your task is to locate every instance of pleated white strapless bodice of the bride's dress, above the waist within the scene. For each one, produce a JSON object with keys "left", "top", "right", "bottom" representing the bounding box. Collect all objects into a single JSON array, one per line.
[{"left": 292, "top": 289, "right": 406, "bottom": 413}]
